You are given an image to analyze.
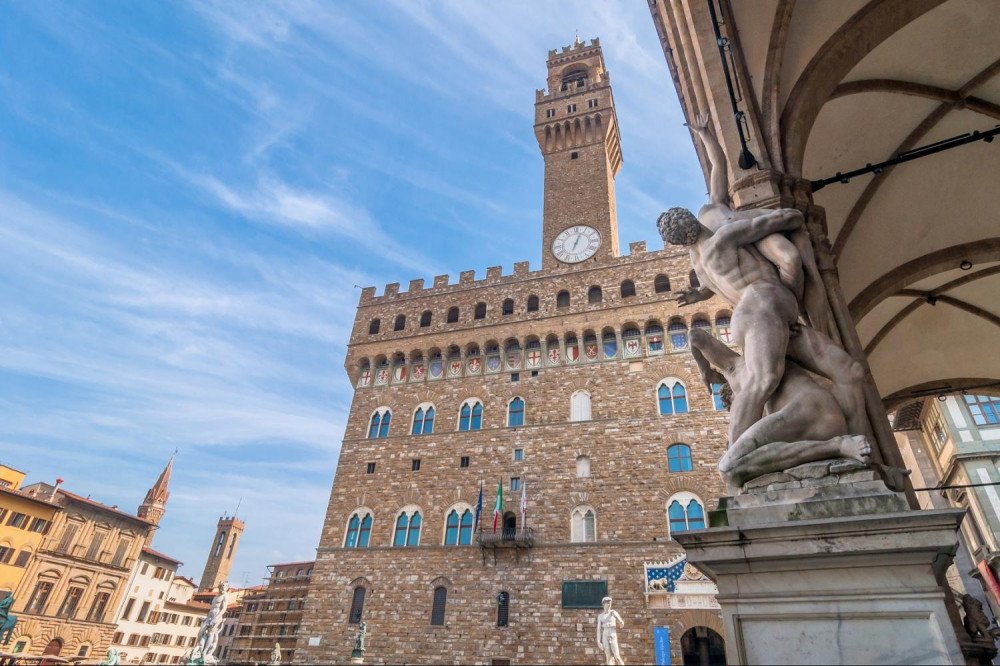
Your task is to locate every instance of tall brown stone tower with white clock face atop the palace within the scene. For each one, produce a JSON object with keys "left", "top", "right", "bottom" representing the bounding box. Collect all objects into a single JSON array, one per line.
[{"left": 535, "top": 37, "right": 622, "bottom": 268}]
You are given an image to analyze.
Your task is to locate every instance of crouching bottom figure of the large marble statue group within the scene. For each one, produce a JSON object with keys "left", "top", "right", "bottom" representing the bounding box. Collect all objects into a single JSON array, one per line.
[{"left": 691, "top": 328, "right": 871, "bottom": 493}]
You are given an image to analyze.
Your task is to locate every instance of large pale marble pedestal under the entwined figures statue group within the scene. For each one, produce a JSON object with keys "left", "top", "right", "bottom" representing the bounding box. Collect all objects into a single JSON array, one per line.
[{"left": 675, "top": 463, "right": 965, "bottom": 664}]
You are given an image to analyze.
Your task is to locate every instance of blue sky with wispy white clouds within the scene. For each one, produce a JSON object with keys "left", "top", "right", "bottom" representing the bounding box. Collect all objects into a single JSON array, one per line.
[{"left": 0, "top": 0, "right": 705, "bottom": 585}]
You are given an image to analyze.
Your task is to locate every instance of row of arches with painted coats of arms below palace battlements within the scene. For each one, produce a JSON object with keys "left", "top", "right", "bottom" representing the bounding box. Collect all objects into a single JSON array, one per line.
[{"left": 357, "top": 311, "right": 733, "bottom": 388}]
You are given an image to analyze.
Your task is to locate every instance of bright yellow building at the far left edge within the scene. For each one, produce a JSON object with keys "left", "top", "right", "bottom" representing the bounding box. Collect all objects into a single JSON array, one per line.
[{"left": 0, "top": 464, "right": 59, "bottom": 597}]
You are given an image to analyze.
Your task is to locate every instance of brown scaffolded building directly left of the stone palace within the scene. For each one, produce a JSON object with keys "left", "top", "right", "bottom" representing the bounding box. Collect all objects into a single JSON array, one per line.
[{"left": 228, "top": 562, "right": 315, "bottom": 664}]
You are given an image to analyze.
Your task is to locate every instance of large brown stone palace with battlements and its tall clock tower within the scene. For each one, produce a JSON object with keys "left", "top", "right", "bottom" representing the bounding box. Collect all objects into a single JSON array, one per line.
[{"left": 295, "top": 40, "right": 730, "bottom": 663}]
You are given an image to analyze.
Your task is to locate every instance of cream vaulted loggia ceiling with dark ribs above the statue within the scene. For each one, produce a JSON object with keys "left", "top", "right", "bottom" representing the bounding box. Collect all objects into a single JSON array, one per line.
[{"left": 650, "top": 0, "right": 1000, "bottom": 404}]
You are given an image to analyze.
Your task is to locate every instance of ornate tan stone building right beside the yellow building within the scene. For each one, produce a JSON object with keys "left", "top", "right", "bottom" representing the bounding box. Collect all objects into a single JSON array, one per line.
[{"left": 6, "top": 482, "right": 154, "bottom": 657}]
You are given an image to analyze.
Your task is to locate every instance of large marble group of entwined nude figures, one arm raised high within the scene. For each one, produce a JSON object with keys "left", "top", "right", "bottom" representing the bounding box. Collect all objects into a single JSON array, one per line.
[{"left": 658, "top": 116, "right": 871, "bottom": 492}]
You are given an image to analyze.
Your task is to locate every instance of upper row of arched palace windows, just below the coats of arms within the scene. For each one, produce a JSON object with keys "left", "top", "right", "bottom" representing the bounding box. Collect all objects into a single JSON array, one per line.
[{"left": 368, "top": 377, "right": 723, "bottom": 439}]
